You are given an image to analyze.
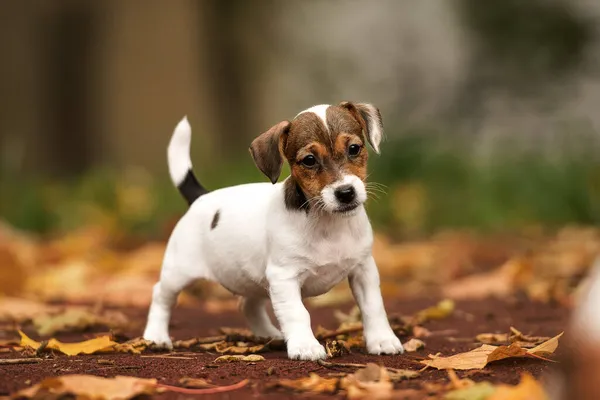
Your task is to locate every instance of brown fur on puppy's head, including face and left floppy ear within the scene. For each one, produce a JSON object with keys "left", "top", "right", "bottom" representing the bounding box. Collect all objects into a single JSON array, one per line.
[{"left": 250, "top": 102, "right": 368, "bottom": 209}]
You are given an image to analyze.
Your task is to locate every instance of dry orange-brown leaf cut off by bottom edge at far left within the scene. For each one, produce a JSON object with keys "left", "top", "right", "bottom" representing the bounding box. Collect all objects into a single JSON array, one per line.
[{"left": 12, "top": 375, "right": 157, "bottom": 400}]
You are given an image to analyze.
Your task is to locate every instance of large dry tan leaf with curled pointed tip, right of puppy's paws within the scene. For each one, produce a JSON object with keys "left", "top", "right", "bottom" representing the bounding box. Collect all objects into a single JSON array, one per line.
[{"left": 421, "top": 333, "right": 563, "bottom": 370}]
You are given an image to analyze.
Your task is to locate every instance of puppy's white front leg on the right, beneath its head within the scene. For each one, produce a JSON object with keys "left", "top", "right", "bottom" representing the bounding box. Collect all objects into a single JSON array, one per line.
[{"left": 348, "top": 256, "right": 404, "bottom": 354}]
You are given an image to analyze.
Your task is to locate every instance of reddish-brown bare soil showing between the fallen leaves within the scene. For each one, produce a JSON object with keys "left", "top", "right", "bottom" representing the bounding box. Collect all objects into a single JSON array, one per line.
[{"left": 0, "top": 299, "right": 568, "bottom": 399}]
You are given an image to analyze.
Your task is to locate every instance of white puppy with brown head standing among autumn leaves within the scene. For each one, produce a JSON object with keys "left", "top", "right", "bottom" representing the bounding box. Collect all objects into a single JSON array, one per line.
[{"left": 144, "top": 102, "right": 404, "bottom": 360}]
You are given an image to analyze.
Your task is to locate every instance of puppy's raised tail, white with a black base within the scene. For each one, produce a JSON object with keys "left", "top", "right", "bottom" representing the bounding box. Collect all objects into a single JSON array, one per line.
[{"left": 167, "top": 116, "right": 208, "bottom": 205}]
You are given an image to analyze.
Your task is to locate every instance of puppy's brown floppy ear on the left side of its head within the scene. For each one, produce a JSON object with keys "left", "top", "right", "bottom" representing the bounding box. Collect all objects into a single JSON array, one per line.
[{"left": 250, "top": 121, "right": 291, "bottom": 183}]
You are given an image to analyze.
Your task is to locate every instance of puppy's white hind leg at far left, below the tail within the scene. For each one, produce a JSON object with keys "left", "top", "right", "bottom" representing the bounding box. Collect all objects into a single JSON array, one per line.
[{"left": 144, "top": 271, "right": 194, "bottom": 349}]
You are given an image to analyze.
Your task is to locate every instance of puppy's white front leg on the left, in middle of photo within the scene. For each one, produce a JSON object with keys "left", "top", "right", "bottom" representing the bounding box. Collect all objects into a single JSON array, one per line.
[{"left": 266, "top": 264, "right": 327, "bottom": 360}]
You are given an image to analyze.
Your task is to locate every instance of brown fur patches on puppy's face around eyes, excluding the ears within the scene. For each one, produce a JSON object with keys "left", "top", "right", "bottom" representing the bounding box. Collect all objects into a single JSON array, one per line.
[{"left": 283, "top": 106, "right": 368, "bottom": 209}]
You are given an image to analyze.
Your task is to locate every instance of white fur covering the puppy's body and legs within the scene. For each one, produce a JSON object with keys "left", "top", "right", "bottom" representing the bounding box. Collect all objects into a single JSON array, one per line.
[{"left": 144, "top": 112, "right": 403, "bottom": 360}]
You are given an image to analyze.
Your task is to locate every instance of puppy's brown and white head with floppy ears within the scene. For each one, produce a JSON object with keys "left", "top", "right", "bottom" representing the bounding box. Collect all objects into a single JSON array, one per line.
[{"left": 250, "top": 102, "right": 383, "bottom": 214}]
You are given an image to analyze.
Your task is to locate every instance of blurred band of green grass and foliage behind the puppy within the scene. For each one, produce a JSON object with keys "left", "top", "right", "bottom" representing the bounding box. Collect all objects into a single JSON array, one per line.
[{"left": 0, "top": 129, "right": 600, "bottom": 235}]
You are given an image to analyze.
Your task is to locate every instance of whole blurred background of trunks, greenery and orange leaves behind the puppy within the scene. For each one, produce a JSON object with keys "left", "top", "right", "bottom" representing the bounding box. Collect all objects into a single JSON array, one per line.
[{"left": 0, "top": 0, "right": 600, "bottom": 305}]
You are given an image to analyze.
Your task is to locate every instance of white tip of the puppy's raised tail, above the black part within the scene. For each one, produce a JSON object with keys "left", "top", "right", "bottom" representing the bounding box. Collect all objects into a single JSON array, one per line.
[{"left": 167, "top": 116, "right": 192, "bottom": 186}]
